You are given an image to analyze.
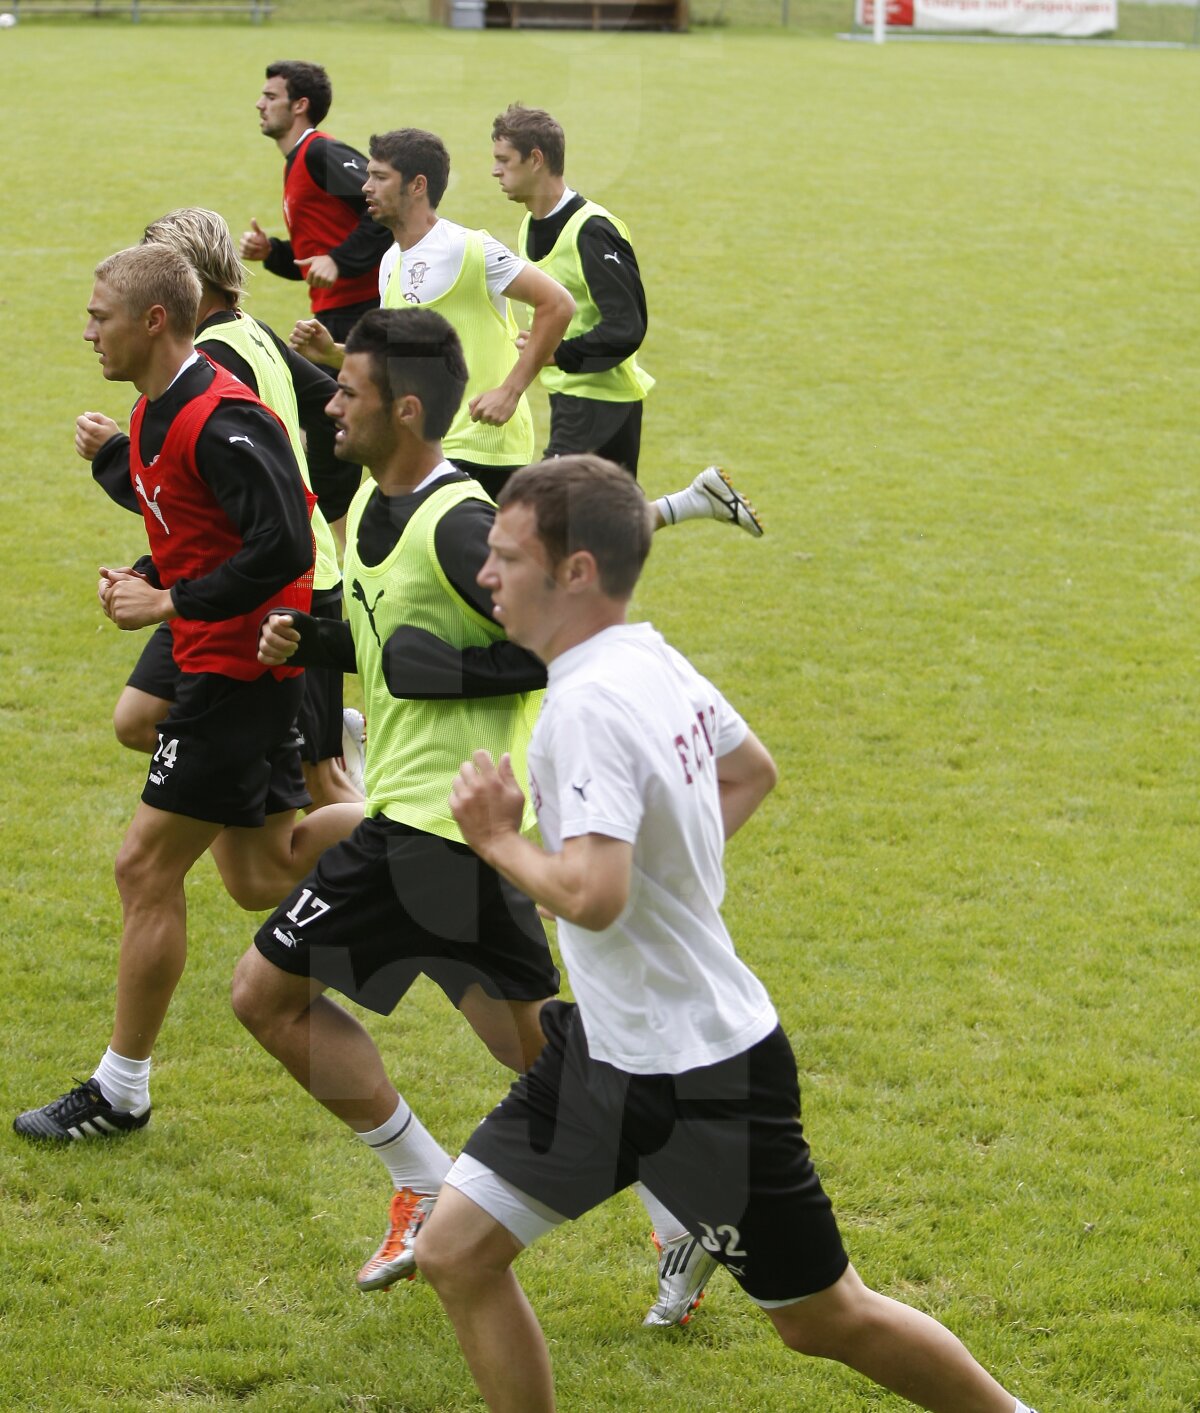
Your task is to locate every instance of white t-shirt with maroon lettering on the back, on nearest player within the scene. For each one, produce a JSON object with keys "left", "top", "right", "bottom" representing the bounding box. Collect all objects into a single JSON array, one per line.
[{"left": 529, "top": 623, "right": 777, "bottom": 1074}]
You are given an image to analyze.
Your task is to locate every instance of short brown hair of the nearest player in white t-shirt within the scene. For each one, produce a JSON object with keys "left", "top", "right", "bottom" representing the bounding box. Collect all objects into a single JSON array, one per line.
[{"left": 498, "top": 452, "right": 653, "bottom": 599}]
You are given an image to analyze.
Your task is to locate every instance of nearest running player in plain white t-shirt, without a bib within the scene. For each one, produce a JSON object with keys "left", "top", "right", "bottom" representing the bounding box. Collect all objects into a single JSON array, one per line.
[{"left": 416, "top": 456, "right": 1025, "bottom": 1413}]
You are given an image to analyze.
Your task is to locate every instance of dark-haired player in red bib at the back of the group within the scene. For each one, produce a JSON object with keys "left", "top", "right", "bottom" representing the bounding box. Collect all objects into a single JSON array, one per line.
[{"left": 240, "top": 59, "right": 392, "bottom": 341}]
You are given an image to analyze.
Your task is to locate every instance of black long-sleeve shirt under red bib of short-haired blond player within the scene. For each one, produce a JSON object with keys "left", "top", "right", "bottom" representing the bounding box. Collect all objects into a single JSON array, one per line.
[{"left": 92, "top": 357, "right": 312, "bottom": 623}]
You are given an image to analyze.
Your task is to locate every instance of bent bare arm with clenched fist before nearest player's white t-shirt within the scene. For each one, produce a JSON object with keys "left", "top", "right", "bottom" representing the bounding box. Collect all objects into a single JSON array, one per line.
[{"left": 449, "top": 750, "right": 633, "bottom": 933}]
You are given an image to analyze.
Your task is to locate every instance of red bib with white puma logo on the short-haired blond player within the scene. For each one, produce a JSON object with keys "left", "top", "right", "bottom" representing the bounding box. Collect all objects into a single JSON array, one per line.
[{"left": 129, "top": 365, "right": 317, "bottom": 681}]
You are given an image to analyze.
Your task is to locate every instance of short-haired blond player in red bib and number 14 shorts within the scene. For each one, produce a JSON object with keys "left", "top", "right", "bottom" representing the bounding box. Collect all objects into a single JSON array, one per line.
[{"left": 13, "top": 246, "right": 360, "bottom": 1140}]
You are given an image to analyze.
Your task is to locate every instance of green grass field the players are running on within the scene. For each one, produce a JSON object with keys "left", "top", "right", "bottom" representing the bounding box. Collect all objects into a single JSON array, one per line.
[{"left": 0, "top": 13, "right": 1200, "bottom": 1413}]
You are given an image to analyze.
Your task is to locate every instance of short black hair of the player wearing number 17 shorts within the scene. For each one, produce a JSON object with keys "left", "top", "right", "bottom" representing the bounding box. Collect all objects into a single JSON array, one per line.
[{"left": 346, "top": 308, "right": 466, "bottom": 441}]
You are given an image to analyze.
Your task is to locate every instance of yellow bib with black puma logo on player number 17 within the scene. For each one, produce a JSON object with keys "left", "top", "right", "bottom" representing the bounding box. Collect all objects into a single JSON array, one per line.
[{"left": 345, "top": 480, "right": 543, "bottom": 842}]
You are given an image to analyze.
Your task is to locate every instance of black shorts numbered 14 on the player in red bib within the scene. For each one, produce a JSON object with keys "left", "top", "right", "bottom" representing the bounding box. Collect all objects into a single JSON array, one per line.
[{"left": 141, "top": 673, "right": 311, "bottom": 828}]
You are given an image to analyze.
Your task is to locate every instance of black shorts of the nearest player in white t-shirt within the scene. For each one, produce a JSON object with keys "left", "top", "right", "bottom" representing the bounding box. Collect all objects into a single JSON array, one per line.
[{"left": 464, "top": 1002, "right": 848, "bottom": 1303}]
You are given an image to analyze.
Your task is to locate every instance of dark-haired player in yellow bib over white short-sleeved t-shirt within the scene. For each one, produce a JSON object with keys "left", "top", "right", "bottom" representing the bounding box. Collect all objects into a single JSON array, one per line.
[{"left": 293, "top": 127, "right": 575, "bottom": 496}]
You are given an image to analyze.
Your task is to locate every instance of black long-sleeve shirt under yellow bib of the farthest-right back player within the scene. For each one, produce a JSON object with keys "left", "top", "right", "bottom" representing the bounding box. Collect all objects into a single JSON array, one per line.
[{"left": 520, "top": 195, "right": 646, "bottom": 373}]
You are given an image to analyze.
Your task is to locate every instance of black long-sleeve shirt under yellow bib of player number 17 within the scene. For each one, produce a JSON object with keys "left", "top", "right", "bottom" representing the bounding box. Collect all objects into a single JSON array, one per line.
[{"left": 281, "top": 472, "right": 546, "bottom": 701}]
